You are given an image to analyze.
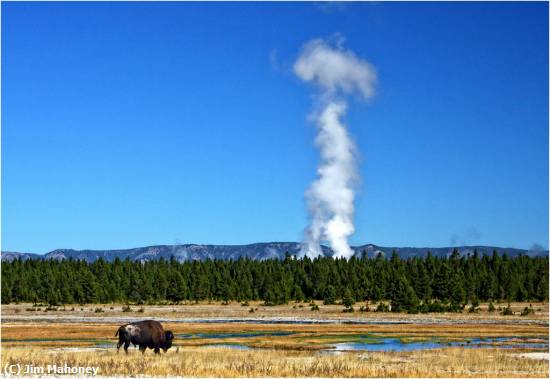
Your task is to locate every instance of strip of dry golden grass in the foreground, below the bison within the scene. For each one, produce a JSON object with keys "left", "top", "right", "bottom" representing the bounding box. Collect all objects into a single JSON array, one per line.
[{"left": 1, "top": 348, "right": 548, "bottom": 377}]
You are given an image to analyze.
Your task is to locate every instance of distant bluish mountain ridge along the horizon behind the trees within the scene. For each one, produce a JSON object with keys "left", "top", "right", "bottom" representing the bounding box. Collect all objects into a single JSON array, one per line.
[{"left": 2, "top": 242, "right": 548, "bottom": 262}]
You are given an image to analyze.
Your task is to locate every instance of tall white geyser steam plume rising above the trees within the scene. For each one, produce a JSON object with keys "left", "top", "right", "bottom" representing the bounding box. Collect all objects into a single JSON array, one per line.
[{"left": 294, "top": 39, "right": 376, "bottom": 258}]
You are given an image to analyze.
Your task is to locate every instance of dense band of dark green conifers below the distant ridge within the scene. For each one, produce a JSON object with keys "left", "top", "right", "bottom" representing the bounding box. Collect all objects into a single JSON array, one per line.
[{"left": 1, "top": 252, "right": 548, "bottom": 312}]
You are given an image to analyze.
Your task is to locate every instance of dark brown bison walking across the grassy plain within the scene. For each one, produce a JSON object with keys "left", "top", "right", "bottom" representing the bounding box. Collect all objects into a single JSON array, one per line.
[{"left": 115, "top": 320, "right": 174, "bottom": 354}]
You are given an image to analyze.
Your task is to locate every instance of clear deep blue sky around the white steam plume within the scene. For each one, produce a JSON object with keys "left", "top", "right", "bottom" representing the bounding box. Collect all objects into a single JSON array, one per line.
[{"left": 1, "top": 2, "right": 548, "bottom": 253}]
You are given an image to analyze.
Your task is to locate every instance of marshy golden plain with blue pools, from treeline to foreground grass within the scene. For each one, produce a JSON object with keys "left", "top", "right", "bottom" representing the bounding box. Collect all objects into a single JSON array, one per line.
[{"left": 1, "top": 303, "right": 548, "bottom": 377}]
